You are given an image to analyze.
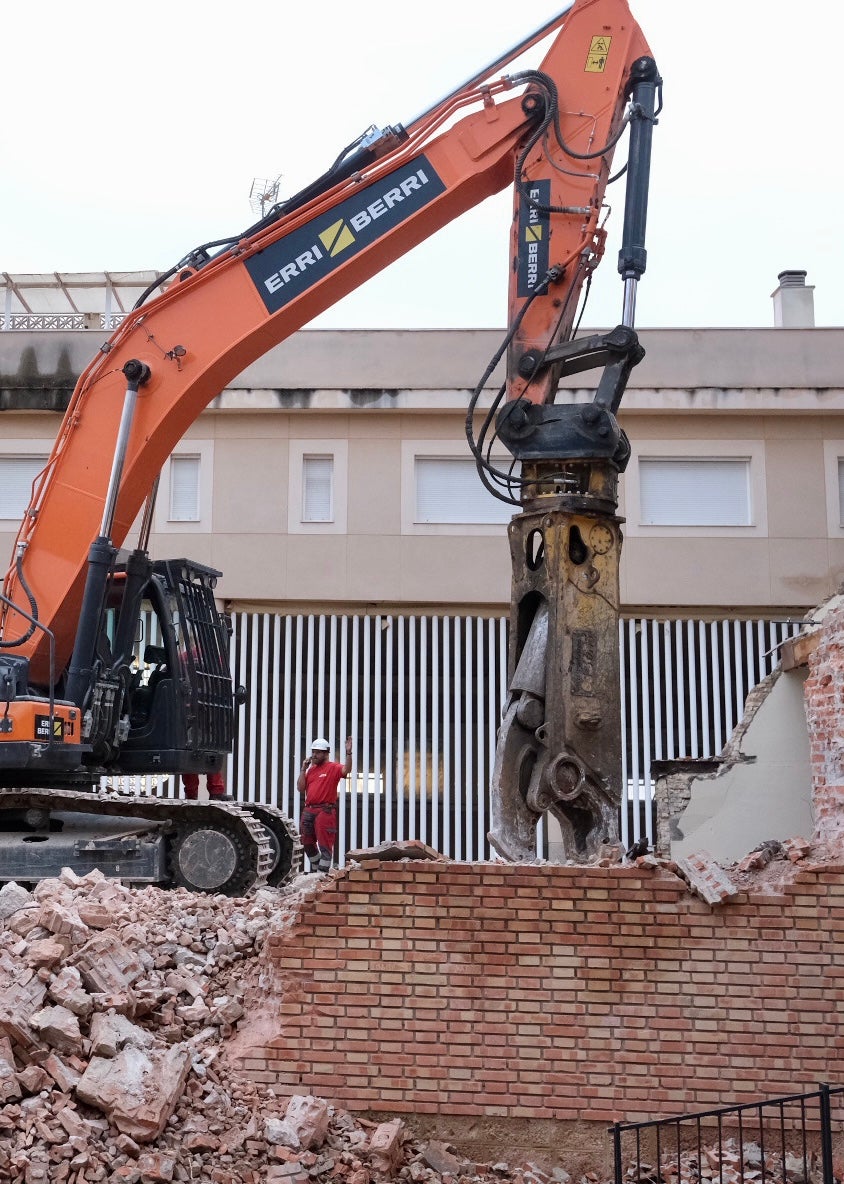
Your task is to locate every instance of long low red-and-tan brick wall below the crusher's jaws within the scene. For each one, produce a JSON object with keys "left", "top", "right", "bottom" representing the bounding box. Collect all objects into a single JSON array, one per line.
[{"left": 239, "top": 862, "right": 844, "bottom": 1124}]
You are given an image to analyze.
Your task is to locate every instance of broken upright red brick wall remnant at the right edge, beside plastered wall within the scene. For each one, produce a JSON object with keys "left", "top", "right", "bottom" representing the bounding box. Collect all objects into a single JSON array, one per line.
[{"left": 804, "top": 597, "right": 844, "bottom": 847}]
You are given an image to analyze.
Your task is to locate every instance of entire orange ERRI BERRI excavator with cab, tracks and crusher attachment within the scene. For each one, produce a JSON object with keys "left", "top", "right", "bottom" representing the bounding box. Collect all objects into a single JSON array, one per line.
[{"left": 0, "top": 0, "right": 662, "bottom": 894}]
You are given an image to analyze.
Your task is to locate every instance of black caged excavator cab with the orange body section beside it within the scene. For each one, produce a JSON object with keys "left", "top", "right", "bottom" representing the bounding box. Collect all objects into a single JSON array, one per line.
[{"left": 0, "top": 552, "right": 233, "bottom": 787}]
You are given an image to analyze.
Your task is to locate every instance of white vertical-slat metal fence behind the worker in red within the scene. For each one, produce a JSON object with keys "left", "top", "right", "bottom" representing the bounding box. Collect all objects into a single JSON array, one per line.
[{"left": 227, "top": 612, "right": 799, "bottom": 863}]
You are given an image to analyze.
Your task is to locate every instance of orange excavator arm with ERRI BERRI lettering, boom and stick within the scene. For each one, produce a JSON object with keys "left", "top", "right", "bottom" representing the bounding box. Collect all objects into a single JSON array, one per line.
[{"left": 0, "top": 0, "right": 657, "bottom": 871}]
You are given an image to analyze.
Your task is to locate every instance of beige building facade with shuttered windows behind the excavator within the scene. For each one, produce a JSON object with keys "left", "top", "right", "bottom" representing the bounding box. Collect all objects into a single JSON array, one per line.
[{"left": 0, "top": 329, "right": 844, "bottom": 616}]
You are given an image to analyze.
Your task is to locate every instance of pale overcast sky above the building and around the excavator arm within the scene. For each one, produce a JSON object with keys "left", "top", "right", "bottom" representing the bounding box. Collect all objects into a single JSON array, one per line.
[{"left": 0, "top": 0, "right": 844, "bottom": 328}]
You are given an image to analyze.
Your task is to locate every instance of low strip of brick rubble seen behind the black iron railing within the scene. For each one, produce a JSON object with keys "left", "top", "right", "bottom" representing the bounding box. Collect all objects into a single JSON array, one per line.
[{"left": 624, "top": 1131, "right": 814, "bottom": 1184}]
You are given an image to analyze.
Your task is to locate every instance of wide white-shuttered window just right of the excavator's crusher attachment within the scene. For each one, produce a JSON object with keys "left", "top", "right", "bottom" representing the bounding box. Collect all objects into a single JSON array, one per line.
[{"left": 639, "top": 457, "right": 752, "bottom": 527}]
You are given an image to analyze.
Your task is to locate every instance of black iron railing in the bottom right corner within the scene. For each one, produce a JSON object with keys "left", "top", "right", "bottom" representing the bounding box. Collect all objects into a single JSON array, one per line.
[{"left": 610, "top": 1085, "right": 844, "bottom": 1184}]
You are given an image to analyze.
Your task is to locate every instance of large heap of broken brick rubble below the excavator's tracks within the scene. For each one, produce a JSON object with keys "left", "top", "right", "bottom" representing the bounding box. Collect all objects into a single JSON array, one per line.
[{"left": 0, "top": 869, "right": 568, "bottom": 1184}]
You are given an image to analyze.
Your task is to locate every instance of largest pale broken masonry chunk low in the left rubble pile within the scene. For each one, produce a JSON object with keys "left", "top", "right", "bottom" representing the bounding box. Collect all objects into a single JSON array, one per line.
[{"left": 76, "top": 1044, "right": 191, "bottom": 1143}]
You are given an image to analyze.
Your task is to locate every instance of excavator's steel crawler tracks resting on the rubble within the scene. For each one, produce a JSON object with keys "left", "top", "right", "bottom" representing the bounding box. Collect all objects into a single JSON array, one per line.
[{"left": 0, "top": 787, "right": 295, "bottom": 896}]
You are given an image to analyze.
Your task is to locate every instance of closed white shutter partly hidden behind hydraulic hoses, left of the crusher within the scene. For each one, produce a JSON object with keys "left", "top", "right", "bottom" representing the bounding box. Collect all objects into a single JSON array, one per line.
[{"left": 415, "top": 456, "right": 516, "bottom": 526}]
